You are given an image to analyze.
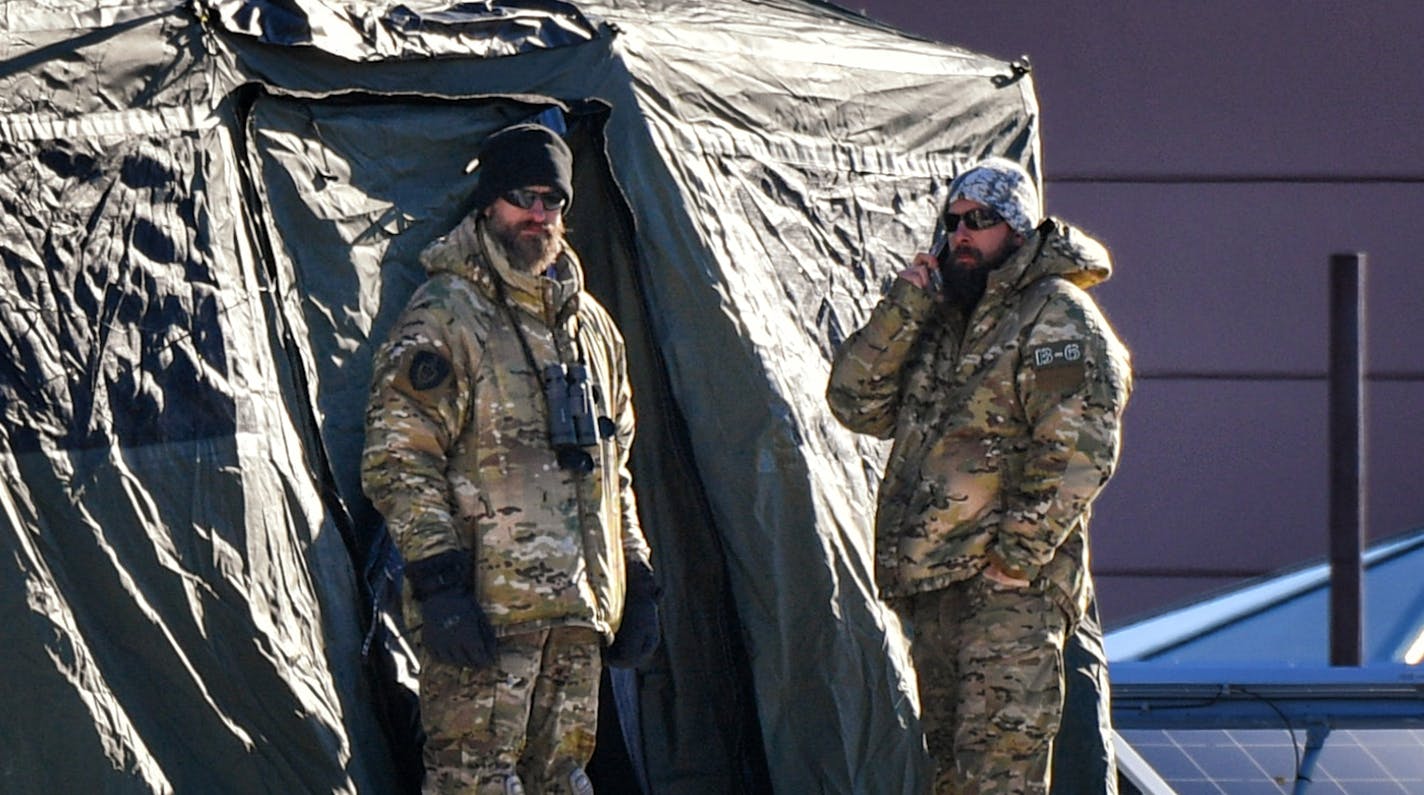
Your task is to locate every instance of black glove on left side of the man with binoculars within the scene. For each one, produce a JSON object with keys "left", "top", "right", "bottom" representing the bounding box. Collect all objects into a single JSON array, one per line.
[{"left": 406, "top": 551, "right": 496, "bottom": 668}]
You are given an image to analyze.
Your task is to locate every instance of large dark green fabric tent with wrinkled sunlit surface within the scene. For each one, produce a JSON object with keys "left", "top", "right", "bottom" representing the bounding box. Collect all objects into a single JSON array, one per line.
[{"left": 0, "top": 0, "right": 1038, "bottom": 794}]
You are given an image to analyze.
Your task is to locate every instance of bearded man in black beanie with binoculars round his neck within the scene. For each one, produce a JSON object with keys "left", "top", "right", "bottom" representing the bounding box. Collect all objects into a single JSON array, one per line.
[{"left": 362, "top": 124, "right": 659, "bottom": 795}]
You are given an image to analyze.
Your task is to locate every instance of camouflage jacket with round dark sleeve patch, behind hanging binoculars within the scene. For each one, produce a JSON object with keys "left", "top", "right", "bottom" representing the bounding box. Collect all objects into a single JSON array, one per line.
[{"left": 362, "top": 214, "right": 648, "bottom": 638}]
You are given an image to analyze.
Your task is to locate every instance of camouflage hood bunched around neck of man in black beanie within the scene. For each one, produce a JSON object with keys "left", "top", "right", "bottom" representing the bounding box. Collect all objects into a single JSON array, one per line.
[{"left": 420, "top": 211, "right": 584, "bottom": 325}]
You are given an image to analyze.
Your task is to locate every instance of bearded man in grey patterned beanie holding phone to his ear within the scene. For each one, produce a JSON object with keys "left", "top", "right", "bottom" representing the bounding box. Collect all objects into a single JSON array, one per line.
[{"left": 827, "top": 158, "right": 1132, "bottom": 795}]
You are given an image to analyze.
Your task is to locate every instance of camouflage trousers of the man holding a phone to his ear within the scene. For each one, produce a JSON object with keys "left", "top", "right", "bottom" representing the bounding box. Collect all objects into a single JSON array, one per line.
[{"left": 891, "top": 577, "right": 1068, "bottom": 795}]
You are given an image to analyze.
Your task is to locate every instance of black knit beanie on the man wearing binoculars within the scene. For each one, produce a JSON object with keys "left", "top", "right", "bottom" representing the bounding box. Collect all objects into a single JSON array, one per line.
[{"left": 473, "top": 124, "right": 574, "bottom": 209}]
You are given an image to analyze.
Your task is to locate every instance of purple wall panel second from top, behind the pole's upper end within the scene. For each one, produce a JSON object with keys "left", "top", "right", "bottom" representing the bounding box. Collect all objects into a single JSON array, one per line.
[{"left": 1047, "top": 184, "right": 1424, "bottom": 376}]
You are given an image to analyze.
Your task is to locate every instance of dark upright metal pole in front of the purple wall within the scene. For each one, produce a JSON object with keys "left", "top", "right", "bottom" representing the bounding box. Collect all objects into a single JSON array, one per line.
[{"left": 1330, "top": 252, "right": 1366, "bottom": 665}]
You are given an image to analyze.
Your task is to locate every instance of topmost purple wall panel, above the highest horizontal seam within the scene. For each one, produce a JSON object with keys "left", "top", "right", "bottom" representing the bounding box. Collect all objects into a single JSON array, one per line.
[{"left": 856, "top": 0, "right": 1424, "bottom": 178}]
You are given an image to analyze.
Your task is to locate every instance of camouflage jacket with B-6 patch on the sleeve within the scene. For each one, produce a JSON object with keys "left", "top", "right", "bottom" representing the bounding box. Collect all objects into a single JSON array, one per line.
[{"left": 827, "top": 219, "right": 1132, "bottom": 618}]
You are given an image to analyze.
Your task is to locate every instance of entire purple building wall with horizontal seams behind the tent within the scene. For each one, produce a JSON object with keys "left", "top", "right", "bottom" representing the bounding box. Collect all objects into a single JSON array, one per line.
[{"left": 854, "top": 0, "right": 1424, "bottom": 625}]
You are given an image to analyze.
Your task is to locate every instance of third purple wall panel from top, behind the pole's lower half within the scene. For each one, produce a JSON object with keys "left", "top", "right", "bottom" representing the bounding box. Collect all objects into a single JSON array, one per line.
[{"left": 1092, "top": 379, "right": 1424, "bottom": 618}]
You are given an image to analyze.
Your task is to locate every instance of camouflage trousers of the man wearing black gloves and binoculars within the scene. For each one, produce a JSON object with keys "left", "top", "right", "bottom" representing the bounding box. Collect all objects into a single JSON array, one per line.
[{"left": 420, "top": 627, "right": 602, "bottom": 795}]
